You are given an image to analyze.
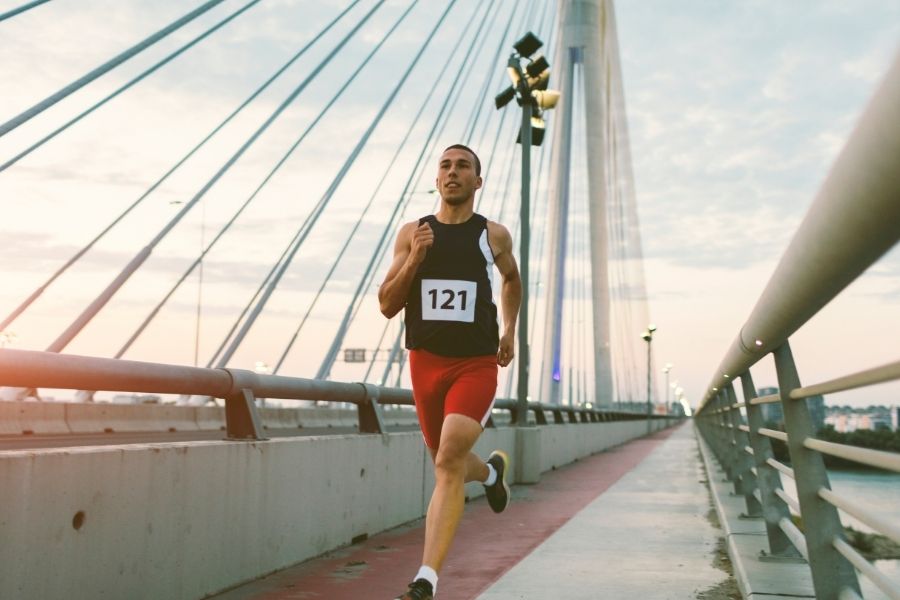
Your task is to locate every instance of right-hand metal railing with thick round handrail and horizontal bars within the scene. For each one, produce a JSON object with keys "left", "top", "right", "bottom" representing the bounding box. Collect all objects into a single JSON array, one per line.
[{"left": 695, "top": 55, "right": 900, "bottom": 600}]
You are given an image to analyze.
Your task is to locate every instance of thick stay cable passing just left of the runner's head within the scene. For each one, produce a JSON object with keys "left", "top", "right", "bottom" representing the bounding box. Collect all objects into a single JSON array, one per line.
[{"left": 310, "top": 5, "right": 510, "bottom": 377}]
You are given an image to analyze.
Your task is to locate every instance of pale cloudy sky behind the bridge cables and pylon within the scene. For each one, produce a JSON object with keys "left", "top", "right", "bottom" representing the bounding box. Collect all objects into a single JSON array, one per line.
[{"left": 0, "top": 0, "right": 900, "bottom": 404}]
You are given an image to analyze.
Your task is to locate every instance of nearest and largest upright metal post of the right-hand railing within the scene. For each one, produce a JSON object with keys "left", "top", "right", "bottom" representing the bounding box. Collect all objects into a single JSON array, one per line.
[{"left": 774, "top": 342, "right": 861, "bottom": 600}]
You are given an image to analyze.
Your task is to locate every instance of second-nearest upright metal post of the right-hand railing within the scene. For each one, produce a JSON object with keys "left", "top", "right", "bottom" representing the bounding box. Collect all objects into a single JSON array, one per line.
[{"left": 741, "top": 371, "right": 803, "bottom": 560}]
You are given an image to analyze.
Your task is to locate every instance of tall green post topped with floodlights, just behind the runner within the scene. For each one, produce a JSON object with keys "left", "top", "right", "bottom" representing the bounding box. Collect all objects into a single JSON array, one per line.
[{"left": 494, "top": 32, "right": 559, "bottom": 426}]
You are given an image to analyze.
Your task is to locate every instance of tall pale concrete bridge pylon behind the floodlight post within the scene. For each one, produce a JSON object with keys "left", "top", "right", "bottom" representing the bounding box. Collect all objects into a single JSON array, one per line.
[{"left": 541, "top": 0, "right": 646, "bottom": 404}]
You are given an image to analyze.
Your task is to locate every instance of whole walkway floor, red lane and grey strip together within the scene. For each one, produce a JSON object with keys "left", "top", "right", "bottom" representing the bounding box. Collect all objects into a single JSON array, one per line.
[{"left": 215, "top": 424, "right": 727, "bottom": 600}]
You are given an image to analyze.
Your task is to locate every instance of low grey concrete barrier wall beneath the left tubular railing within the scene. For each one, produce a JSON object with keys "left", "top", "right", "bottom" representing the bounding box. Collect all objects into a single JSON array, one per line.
[{"left": 0, "top": 422, "right": 680, "bottom": 600}]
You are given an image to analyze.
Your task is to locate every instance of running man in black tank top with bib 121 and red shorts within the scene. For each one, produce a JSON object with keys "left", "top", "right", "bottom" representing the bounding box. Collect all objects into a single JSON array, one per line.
[{"left": 378, "top": 144, "right": 522, "bottom": 600}]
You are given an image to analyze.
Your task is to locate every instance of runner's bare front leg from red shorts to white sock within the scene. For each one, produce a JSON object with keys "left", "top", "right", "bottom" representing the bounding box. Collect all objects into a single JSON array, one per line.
[{"left": 422, "top": 414, "right": 488, "bottom": 573}]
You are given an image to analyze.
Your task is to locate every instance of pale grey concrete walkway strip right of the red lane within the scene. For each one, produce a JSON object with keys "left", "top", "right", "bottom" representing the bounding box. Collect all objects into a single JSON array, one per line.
[{"left": 478, "top": 423, "right": 727, "bottom": 600}]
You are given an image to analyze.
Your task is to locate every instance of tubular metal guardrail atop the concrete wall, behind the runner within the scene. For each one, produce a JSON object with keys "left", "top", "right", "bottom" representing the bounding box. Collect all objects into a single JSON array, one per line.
[{"left": 0, "top": 349, "right": 672, "bottom": 440}]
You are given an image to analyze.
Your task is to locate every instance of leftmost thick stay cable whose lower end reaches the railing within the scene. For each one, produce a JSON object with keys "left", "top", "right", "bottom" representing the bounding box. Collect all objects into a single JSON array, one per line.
[{"left": 37, "top": 0, "right": 385, "bottom": 360}]
